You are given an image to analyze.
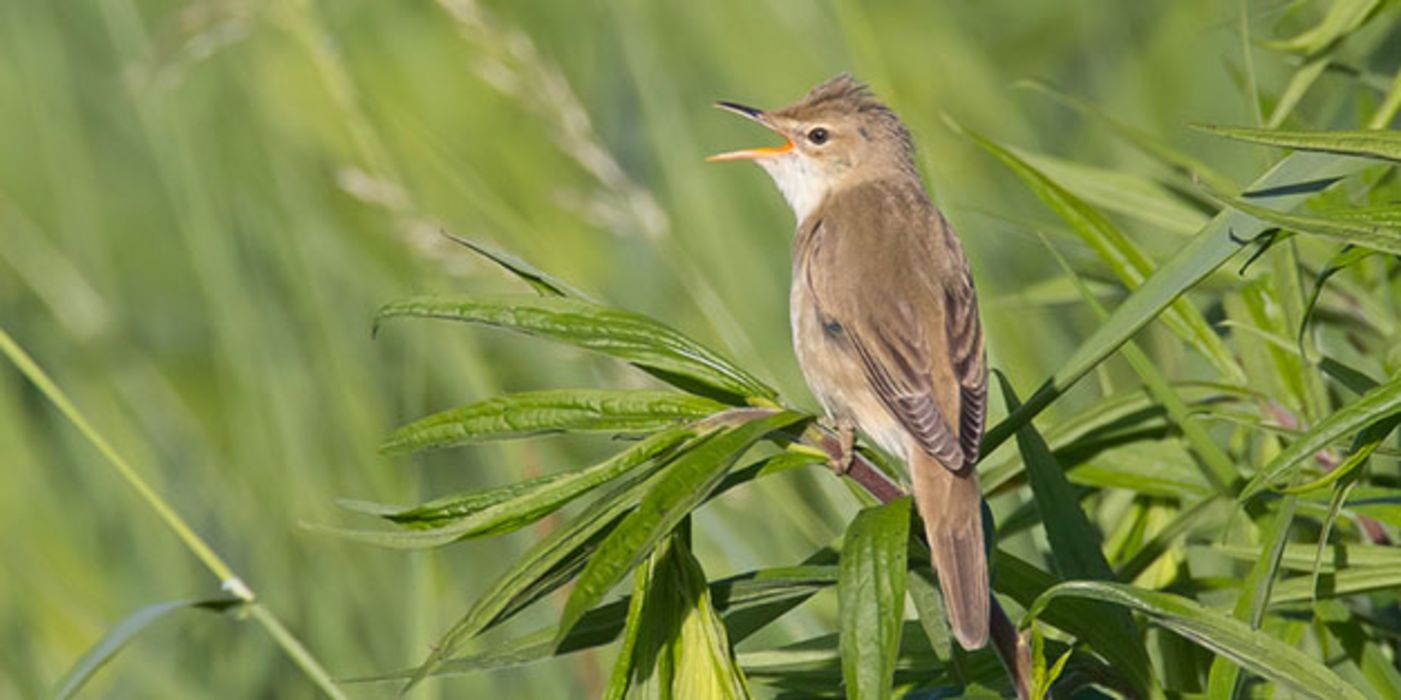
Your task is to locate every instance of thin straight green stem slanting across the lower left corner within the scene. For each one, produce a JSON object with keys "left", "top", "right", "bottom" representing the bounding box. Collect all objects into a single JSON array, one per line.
[{"left": 0, "top": 328, "right": 345, "bottom": 700}]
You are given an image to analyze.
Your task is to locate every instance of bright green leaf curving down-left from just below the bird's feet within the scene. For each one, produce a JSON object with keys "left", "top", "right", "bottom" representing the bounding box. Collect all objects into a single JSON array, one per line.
[{"left": 559, "top": 412, "right": 804, "bottom": 644}]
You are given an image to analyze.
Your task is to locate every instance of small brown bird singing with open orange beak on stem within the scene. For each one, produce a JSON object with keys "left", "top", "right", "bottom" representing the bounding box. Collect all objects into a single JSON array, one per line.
[{"left": 710, "top": 74, "right": 991, "bottom": 650}]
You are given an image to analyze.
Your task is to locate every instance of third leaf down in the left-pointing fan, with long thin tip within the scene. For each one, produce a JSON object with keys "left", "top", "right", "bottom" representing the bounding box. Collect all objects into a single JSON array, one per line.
[{"left": 314, "top": 428, "right": 695, "bottom": 549}]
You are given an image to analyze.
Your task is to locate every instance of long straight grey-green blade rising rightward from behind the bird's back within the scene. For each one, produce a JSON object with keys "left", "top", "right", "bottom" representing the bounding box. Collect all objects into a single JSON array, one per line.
[{"left": 982, "top": 153, "right": 1366, "bottom": 454}]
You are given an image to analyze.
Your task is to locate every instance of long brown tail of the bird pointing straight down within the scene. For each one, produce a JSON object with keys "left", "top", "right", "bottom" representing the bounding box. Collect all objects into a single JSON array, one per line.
[{"left": 909, "top": 447, "right": 991, "bottom": 650}]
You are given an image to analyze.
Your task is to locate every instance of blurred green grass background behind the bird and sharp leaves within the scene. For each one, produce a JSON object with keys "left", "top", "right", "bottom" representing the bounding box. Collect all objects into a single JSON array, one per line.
[{"left": 0, "top": 0, "right": 1395, "bottom": 697}]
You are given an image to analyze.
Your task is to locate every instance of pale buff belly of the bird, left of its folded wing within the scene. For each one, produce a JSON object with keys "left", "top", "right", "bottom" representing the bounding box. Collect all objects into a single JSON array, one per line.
[{"left": 789, "top": 278, "right": 908, "bottom": 456}]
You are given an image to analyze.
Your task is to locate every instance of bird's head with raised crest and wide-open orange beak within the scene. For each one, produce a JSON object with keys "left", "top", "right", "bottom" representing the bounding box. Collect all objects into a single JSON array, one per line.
[{"left": 708, "top": 73, "right": 915, "bottom": 221}]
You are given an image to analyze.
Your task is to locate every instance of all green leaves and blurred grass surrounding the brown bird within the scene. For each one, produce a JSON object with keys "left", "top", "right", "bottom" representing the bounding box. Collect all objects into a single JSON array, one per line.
[{"left": 10, "top": 0, "right": 1401, "bottom": 699}]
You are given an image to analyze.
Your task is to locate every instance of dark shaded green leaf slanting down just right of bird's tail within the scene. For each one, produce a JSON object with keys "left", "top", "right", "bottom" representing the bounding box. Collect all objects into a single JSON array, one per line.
[{"left": 996, "top": 372, "right": 1153, "bottom": 696}]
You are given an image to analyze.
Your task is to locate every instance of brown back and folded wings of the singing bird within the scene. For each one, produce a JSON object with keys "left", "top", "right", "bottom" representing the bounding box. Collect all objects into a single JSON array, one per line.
[{"left": 824, "top": 194, "right": 988, "bottom": 472}]
